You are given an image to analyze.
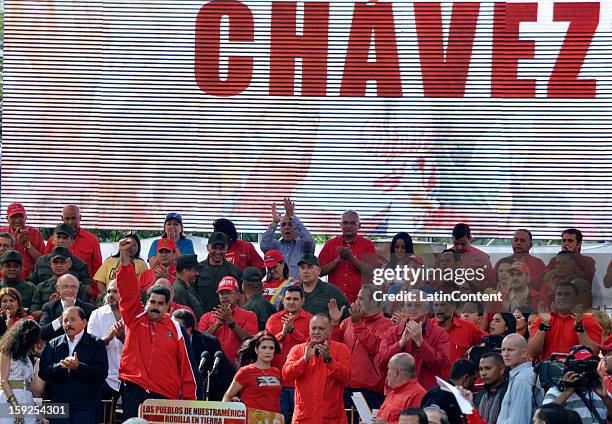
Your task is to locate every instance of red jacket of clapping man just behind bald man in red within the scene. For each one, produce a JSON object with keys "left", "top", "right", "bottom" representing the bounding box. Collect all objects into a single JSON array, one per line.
[{"left": 376, "top": 320, "right": 450, "bottom": 390}]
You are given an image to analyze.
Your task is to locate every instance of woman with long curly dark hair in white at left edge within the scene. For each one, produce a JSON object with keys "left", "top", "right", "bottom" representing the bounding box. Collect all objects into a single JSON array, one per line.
[{"left": 0, "top": 318, "right": 45, "bottom": 424}]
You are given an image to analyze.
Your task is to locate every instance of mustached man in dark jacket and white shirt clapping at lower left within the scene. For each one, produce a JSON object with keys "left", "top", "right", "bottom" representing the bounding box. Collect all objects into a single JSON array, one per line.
[{"left": 38, "top": 306, "right": 108, "bottom": 424}]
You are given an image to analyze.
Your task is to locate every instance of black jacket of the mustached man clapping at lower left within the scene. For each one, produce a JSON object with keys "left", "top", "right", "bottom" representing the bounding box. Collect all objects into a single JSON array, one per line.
[{"left": 38, "top": 332, "right": 108, "bottom": 411}]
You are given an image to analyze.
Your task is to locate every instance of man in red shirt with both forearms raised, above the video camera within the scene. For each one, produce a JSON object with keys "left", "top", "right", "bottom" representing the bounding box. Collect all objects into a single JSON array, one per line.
[{"left": 528, "top": 281, "right": 602, "bottom": 360}]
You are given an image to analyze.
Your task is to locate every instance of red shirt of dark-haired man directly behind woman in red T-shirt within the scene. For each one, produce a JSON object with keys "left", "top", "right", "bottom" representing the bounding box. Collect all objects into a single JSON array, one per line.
[{"left": 266, "top": 309, "right": 312, "bottom": 376}]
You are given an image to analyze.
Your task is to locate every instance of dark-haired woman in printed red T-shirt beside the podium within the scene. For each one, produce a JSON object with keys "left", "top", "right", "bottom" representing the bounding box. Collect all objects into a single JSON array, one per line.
[{"left": 223, "top": 331, "right": 282, "bottom": 412}]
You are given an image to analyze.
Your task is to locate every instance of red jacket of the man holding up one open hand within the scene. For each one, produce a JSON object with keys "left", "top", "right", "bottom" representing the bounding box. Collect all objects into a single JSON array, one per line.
[{"left": 332, "top": 313, "right": 393, "bottom": 393}]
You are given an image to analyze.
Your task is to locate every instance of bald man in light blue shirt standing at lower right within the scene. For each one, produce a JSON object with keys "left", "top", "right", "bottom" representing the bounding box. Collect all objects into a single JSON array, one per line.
[{"left": 497, "top": 333, "right": 542, "bottom": 424}]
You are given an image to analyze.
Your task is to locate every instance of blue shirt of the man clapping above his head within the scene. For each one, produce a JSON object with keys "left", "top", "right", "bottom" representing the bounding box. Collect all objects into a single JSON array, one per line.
[{"left": 259, "top": 216, "right": 315, "bottom": 280}]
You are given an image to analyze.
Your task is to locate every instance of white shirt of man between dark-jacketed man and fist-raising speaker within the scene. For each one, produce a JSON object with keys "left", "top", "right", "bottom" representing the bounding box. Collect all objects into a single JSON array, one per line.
[{"left": 87, "top": 305, "right": 123, "bottom": 391}]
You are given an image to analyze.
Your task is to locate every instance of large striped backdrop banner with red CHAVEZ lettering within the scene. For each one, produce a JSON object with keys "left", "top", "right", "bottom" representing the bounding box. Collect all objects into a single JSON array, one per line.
[{"left": 1, "top": 0, "right": 612, "bottom": 239}]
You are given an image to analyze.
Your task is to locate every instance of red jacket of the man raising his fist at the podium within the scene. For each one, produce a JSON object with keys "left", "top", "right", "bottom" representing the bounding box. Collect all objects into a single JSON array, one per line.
[{"left": 117, "top": 265, "right": 196, "bottom": 400}]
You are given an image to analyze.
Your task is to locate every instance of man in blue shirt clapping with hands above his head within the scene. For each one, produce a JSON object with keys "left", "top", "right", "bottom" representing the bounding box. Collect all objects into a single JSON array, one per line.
[{"left": 260, "top": 197, "right": 316, "bottom": 278}]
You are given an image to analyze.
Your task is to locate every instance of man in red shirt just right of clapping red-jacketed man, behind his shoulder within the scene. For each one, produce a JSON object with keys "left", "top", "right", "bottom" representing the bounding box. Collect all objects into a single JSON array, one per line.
[{"left": 431, "top": 301, "right": 483, "bottom": 380}]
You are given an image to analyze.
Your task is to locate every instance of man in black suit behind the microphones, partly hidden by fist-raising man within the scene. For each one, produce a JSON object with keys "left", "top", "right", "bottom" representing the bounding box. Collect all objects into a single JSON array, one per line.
[{"left": 172, "top": 309, "right": 236, "bottom": 401}]
